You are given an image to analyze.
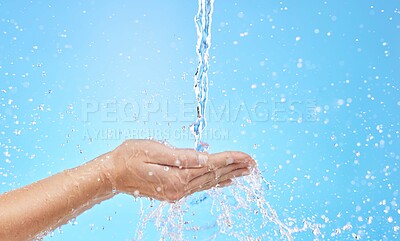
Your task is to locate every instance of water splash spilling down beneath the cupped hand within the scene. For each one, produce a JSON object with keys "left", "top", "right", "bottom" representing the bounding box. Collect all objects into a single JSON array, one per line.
[{"left": 134, "top": 170, "right": 323, "bottom": 241}]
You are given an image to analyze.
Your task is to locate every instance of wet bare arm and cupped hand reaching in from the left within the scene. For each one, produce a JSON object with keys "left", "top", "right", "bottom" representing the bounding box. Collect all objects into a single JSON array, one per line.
[{"left": 0, "top": 140, "right": 256, "bottom": 241}]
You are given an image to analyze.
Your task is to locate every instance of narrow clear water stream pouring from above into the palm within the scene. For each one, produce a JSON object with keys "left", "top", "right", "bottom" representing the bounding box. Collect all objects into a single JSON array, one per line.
[{"left": 190, "top": 0, "right": 214, "bottom": 151}]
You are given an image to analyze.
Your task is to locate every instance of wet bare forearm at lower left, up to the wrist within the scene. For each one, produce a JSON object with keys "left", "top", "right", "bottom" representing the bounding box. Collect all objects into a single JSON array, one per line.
[{"left": 0, "top": 155, "right": 113, "bottom": 241}]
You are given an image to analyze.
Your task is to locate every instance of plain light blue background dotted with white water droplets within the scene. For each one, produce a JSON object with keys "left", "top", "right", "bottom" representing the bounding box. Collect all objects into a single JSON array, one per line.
[{"left": 0, "top": 0, "right": 400, "bottom": 240}]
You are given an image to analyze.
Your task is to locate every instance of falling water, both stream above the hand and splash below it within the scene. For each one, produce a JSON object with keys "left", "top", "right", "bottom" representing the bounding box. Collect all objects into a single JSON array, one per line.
[{"left": 136, "top": 0, "right": 320, "bottom": 241}]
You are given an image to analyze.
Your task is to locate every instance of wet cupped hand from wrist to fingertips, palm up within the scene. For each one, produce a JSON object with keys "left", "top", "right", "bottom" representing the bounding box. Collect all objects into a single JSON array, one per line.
[{"left": 103, "top": 140, "right": 256, "bottom": 202}]
